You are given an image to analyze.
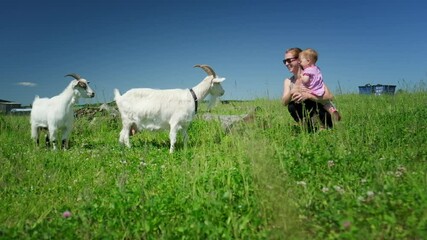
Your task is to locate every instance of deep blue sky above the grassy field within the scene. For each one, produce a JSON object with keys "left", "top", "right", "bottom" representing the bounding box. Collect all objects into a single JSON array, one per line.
[{"left": 0, "top": 0, "right": 427, "bottom": 105}]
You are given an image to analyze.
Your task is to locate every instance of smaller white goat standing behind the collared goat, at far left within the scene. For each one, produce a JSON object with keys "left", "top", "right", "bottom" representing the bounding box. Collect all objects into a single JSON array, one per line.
[{"left": 31, "top": 73, "right": 95, "bottom": 149}]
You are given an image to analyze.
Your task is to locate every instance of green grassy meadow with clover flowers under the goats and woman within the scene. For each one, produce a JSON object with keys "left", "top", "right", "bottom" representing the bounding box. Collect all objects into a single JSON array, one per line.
[{"left": 0, "top": 91, "right": 427, "bottom": 239}]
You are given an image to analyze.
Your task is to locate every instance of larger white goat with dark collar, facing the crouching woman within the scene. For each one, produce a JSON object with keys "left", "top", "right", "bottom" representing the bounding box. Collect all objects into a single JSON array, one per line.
[{"left": 114, "top": 65, "right": 225, "bottom": 153}]
